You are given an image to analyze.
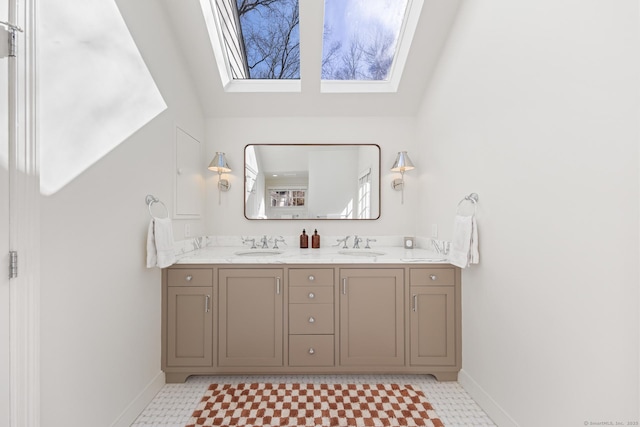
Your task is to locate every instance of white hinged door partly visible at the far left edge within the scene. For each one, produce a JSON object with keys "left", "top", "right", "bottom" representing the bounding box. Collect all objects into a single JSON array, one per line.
[{"left": 0, "top": 0, "right": 11, "bottom": 427}]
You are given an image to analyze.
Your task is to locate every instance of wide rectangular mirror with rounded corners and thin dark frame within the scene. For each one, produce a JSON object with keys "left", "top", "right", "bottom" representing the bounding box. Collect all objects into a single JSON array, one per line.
[{"left": 244, "top": 144, "right": 380, "bottom": 220}]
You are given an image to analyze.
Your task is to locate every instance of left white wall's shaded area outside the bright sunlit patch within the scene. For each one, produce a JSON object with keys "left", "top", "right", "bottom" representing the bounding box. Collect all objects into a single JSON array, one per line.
[{"left": 41, "top": 0, "right": 204, "bottom": 427}]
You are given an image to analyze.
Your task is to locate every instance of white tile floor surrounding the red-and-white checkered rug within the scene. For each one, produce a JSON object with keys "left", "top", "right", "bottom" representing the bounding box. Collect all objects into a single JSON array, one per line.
[{"left": 131, "top": 375, "right": 495, "bottom": 427}]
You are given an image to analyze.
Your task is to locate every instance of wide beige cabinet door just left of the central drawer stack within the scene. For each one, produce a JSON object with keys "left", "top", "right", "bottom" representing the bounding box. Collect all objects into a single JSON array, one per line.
[{"left": 218, "top": 269, "right": 284, "bottom": 366}]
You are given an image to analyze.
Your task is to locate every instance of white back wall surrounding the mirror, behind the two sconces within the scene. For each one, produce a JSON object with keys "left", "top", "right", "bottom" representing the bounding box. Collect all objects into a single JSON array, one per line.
[{"left": 206, "top": 117, "right": 421, "bottom": 236}]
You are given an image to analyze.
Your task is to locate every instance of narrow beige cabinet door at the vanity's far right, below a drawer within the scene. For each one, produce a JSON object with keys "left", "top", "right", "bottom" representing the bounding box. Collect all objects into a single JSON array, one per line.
[{"left": 411, "top": 286, "right": 456, "bottom": 366}]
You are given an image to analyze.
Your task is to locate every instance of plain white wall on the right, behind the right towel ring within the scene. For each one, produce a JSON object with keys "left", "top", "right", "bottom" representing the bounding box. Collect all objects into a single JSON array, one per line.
[{"left": 417, "top": 0, "right": 640, "bottom": 426}]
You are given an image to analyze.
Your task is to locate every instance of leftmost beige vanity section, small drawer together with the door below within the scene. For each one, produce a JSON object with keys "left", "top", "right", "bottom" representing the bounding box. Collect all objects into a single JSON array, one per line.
[{"left": 162, "top": 268, "right": 213, "bottom": 368}]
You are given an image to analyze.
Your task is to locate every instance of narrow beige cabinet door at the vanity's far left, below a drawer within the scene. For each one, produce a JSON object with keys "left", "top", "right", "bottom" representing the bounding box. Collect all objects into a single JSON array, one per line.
[{"left": 167, "top": 286, "right": 213, "bottom": 366}]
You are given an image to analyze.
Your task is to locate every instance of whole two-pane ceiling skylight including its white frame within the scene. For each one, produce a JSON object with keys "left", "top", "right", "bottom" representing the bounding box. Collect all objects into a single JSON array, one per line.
[{"left": 200, "top": 0, "right": 424, "bottom": 92}]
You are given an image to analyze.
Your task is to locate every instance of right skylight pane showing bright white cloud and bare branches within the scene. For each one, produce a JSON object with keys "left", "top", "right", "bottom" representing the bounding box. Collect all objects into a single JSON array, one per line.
[{"left": 322, "top": 0, "right": 408, "bottom": 81}]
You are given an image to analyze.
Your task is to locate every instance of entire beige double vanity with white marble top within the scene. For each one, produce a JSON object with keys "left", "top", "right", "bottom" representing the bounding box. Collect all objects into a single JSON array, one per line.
[{"left": 162, "top": 246, "right": 461, "bottom": 382}]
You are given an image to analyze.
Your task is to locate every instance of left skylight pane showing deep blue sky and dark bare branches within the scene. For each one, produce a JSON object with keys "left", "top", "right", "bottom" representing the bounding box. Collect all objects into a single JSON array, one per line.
[{"left": 234, "top": 0, "right": 300, "bottom": 80}]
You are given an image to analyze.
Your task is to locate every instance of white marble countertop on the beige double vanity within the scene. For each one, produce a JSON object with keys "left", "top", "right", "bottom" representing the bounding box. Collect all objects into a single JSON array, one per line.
[{"left": 176, "top": 246, "right": 448, "bottom": 264}]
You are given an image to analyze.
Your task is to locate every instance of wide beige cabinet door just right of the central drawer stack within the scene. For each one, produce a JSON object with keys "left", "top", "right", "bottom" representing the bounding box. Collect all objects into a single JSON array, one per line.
[{"left": 340, "top": 269, "right": 405, "bottom": 366}]
